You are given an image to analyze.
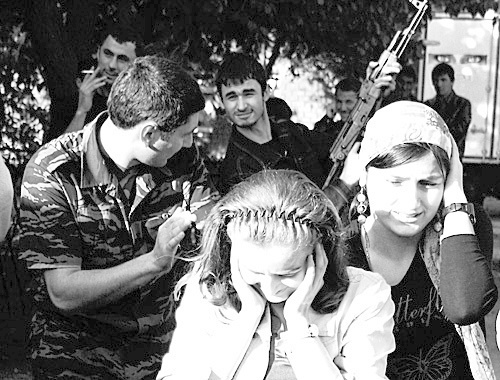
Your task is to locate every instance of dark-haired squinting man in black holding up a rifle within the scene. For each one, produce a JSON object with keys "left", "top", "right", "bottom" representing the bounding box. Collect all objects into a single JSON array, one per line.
[{"left": 216, "top": 53, "right": 400, "bottom": 217}]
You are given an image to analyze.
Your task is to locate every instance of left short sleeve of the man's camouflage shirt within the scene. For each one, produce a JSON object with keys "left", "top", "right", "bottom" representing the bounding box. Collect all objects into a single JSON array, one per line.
[{"left": 19, "top": 160, "right": 82, "bottom": 269}]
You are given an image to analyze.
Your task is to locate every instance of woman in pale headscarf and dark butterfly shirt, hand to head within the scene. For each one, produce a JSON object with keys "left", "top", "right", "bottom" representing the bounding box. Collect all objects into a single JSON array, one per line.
[{"left": 348, "top": 101, "right": 497, "bottom": 380}]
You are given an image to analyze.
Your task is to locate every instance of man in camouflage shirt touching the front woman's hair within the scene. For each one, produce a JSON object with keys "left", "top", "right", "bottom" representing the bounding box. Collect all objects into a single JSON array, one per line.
[{"left": 20, "top": 57, "right": 216, "bottom": 379}]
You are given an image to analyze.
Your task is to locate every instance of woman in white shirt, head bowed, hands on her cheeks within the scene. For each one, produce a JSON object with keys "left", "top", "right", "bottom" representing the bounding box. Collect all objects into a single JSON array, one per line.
[{"left": 157, "top": 170, "right": 394, "bottom": 380}]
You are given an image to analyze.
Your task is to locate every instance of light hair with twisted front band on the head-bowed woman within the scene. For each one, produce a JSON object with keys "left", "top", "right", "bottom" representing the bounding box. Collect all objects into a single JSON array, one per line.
[{"left": 178, "top": 170, "right": 349, "bottom": 313}]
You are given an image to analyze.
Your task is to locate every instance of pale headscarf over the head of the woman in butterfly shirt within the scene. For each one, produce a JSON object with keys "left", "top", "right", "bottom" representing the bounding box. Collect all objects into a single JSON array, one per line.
[{"left": 359, "top": 101, "right": 453, "bottom": 167}]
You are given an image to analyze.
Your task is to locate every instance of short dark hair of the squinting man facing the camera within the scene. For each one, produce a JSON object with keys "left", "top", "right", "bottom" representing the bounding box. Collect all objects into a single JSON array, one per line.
[{"left": 215, "top": 53, "right": 267, "bottom": 95}]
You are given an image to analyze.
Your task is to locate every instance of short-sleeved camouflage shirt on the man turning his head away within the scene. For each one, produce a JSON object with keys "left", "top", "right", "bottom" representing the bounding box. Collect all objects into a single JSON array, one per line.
[{"left": 19, "top": 117, "right": 216, "bottom": 378}]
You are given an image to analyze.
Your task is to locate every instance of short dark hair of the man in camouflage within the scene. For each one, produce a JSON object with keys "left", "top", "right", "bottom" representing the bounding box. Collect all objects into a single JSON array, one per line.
[{"left": 108, "top": 56, "right": 205, "bottom": 132}]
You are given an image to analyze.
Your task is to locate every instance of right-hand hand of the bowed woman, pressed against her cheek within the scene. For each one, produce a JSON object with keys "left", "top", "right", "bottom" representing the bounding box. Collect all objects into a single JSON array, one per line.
[{"left": 283, "top": 243, "right": 328, "bottom": 332}]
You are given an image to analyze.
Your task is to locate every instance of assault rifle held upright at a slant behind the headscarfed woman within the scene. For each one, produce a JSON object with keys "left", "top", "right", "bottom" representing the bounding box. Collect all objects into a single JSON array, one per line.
[{"left": 323, "top": 0, "right": 428, "bottom": 189}]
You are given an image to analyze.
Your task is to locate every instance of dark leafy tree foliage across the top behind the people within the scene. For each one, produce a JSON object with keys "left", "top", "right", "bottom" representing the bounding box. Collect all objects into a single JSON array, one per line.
[{"left": 0, "top": 0, "right": 498, "bottom": 177}]
